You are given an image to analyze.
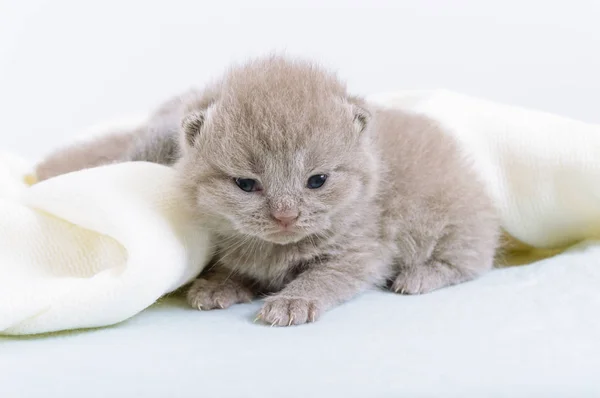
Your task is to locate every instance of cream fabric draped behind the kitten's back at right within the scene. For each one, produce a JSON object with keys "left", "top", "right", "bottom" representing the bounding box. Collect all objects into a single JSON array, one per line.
[{"left": 370, "top": 91, "right": 600, "bottom": 249}]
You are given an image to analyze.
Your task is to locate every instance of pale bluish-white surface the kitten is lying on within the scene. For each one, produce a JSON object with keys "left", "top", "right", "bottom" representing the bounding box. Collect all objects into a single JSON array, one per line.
[{"left": 0, "top": 246, "right": 600, "bottom": 398}]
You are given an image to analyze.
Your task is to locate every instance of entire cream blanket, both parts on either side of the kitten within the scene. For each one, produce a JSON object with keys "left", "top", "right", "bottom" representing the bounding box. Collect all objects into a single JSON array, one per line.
[{"left": 0, "top": 91, "right": 600, "bottom": 334}]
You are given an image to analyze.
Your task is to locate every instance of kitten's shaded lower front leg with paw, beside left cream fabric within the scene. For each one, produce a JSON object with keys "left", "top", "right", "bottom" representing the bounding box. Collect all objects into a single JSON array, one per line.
[{"left": 187, "top": 266, "right": 256, "bottom": 310}]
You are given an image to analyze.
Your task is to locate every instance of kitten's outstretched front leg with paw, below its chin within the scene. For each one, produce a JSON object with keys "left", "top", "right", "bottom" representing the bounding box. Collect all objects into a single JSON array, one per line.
[{"left": 257, "top": 252, "right": 386, "bottom": 326}]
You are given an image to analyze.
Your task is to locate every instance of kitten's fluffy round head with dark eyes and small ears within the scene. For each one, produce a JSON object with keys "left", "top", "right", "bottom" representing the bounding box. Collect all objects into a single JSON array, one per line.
[{"left": 178, "top": 57, "right": 376, "bottom": 244}]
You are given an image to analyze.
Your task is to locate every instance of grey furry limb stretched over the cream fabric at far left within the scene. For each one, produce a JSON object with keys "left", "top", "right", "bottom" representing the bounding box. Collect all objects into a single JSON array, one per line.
[{"left": 35, "top": 131, "right": 137, "bottom": 181}]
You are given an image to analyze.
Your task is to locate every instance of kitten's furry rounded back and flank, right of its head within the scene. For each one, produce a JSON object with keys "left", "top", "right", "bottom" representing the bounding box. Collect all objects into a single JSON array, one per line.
[{"left": 375, "top": 109, "right": 499, "bottom": 277}]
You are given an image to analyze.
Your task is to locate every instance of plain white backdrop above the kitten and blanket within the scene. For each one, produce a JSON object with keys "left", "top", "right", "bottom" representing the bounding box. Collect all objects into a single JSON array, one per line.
[{"left": 0, "top": 0, "right": 600, "bottom": 157}]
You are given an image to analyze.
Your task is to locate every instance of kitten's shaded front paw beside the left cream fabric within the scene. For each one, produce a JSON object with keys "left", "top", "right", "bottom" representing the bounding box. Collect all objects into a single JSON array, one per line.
[{"left": 187, "top": 278, "right": 253, "bottom": 310}]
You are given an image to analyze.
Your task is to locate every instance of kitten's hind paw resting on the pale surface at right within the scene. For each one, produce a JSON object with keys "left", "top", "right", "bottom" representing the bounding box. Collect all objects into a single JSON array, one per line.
[{"left": 391, "top": 262, "right": 464, "bottom": 294}]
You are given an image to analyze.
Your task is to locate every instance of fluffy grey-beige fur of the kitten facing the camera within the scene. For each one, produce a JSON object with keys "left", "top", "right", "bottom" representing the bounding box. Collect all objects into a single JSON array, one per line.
[{"left": 35, "top": 57, "right": 499, "bottom": 325}]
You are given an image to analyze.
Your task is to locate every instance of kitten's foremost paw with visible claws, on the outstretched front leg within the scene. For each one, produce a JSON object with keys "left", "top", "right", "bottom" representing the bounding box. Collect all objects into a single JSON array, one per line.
[{"left": 256, "top": 296, "right": 321, "bottom": 326}]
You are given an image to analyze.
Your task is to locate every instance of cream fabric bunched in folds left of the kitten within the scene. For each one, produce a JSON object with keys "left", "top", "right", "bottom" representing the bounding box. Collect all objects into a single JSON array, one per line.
[{"left": 0, "top": 155, "right": 211, "bottom": 334}]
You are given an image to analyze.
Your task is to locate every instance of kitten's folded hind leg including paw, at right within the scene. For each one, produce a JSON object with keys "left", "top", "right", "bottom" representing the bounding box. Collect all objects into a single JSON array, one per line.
[{"left": 391, "top": 218, "right": 498, "bottom": 294}]
